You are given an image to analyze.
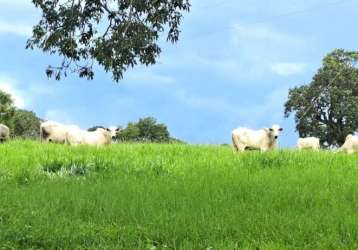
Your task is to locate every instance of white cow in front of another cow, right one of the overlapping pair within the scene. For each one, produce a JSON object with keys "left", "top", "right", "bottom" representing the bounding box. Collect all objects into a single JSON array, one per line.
[{"left": 66, "top": 128, "right": 112, "bottom": 146}]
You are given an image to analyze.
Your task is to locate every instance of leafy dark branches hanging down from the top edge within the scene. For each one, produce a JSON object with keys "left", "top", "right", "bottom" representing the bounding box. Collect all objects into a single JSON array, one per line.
[{"left": 26, "top": 0, "right": 190, "bottom": 82}]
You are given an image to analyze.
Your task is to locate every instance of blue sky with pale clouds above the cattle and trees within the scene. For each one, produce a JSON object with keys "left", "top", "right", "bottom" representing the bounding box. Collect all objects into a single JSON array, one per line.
[{"left": 0, "top": 0, "right": 358, "bottom": 147}]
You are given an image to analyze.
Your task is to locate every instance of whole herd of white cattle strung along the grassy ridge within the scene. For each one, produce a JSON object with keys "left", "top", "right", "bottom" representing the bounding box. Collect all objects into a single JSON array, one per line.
[{"left": 0, "top": 121, "right": 358, "bottom": 154}]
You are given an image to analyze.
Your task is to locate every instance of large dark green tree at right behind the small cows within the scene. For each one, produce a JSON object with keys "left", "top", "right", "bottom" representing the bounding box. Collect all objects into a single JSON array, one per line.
[{"left": 285, "top": 49, "right": 358, "bottom": 146}]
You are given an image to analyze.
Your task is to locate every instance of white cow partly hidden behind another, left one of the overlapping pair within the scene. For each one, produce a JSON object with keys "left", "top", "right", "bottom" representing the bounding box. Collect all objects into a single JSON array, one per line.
[{"left": 40, "top": 121, "right": 80, "bottom": 143}]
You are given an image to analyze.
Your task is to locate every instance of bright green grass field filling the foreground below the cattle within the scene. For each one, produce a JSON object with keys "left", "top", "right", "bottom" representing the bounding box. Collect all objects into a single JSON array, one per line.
[{"left": 0, "top": 141, "right": 358, "bottom": 249}]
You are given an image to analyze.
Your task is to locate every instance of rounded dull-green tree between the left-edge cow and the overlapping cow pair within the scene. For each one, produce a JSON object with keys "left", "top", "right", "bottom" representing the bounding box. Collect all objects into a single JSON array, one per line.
[{"left": 12, "top": 109, "right": 41, "bottom": 139}]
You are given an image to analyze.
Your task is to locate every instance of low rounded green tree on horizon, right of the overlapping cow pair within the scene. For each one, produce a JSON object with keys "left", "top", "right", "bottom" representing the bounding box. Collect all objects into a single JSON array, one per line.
[{"left": 118, "top": 117, "right": 171, "bottom": 142}]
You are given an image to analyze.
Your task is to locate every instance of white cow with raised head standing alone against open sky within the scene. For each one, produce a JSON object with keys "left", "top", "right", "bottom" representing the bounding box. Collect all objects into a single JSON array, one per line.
[{"left": 232, "top": 125, "right": 283, "bottom": 152}]
